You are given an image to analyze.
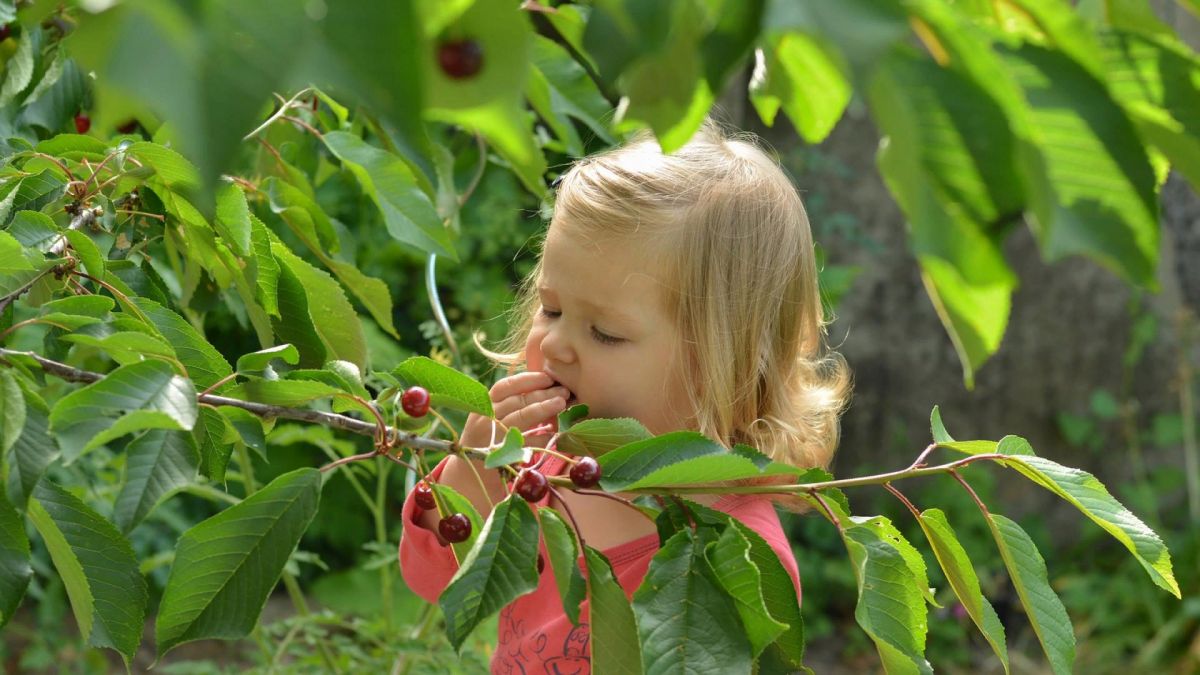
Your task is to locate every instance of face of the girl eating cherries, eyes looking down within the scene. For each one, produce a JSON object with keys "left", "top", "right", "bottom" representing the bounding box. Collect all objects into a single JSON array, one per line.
[{"left": 526, "top": 226, "right": 694, "bottom": 434}]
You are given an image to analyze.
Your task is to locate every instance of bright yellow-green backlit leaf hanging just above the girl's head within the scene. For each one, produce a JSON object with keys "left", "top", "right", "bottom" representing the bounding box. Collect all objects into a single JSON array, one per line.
[{"left": 750, "top": 32, "right": 851, "bottom": 143}]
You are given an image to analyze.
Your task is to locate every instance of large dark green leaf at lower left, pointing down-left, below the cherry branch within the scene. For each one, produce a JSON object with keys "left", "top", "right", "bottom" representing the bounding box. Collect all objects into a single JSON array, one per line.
[{"left": 155, "top": 468, "right": 322, "bottom": 658}]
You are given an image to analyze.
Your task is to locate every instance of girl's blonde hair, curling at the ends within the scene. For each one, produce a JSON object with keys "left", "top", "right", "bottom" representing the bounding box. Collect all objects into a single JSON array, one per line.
[{"left": 476, "top": 119, "right": 851, "bottom": 482}]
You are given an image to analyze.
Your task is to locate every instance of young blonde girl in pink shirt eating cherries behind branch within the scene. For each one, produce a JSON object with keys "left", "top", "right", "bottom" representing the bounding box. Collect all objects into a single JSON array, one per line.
[{"left": 400, "top": 115, "right": 850, "bottom": 674}]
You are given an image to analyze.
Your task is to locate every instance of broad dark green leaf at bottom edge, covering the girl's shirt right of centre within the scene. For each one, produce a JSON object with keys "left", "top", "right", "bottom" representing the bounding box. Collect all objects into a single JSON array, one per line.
[{"left": 634, "top": 527, "right": 752, "bottom": 674}]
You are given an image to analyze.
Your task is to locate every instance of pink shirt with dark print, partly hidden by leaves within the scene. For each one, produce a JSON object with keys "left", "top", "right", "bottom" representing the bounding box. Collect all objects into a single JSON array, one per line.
[{"left": 400, "top": 449, "right": 800, "bottom": 675}]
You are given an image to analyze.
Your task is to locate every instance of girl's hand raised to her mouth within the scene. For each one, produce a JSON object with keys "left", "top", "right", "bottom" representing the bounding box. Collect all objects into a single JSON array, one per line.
[{"left": 460, "top": 372, "right": 571, "bottom": 448}]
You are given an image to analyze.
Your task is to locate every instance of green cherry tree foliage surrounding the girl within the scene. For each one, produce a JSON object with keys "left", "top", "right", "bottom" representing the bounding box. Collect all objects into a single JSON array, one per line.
[{"left": 0, "top": 0, "right": 1185, "bottom": 673}]
